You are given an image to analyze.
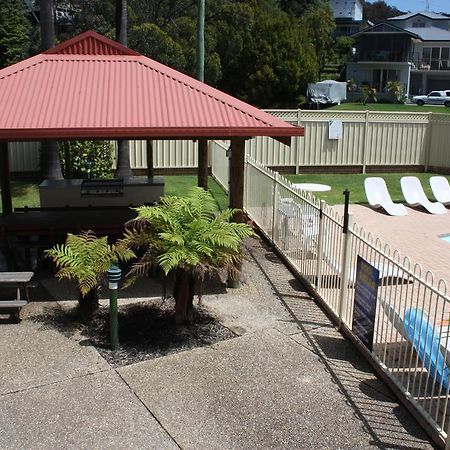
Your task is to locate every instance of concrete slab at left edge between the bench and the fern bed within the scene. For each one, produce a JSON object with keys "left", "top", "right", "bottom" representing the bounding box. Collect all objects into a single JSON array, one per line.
[{"left": 0, "top": 303, "right": 110, "bottom": 394}]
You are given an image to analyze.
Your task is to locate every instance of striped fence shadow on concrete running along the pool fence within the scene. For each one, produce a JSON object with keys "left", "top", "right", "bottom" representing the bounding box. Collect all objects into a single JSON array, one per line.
[{"left": 248, "top": 237, "right": 433, "bottom": 450}]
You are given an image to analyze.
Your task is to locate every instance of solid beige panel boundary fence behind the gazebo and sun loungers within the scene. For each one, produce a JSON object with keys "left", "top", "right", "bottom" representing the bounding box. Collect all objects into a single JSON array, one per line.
[{"left": 6, "top": 110, "right": 450, "bottom": 172}]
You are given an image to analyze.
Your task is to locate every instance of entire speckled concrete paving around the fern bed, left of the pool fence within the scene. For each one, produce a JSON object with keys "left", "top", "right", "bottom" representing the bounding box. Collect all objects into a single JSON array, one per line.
[{"left": 0, "top": 241, "right": 432, "bottom": 450}]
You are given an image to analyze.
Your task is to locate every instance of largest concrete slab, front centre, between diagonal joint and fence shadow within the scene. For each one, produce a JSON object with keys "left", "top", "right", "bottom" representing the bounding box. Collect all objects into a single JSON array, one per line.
[{"left": 119, "top": 329, "right": 400, "bottom": 449}]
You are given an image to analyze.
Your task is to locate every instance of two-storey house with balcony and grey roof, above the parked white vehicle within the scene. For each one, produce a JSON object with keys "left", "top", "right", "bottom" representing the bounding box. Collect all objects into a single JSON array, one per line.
[{"left": 346, "top": 11, "right": 450, "bottom": 96}]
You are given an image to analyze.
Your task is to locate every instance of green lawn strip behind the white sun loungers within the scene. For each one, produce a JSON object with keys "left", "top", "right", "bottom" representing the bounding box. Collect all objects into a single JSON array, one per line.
[{"left": 287, "top": 173, "right": 450, "bottom": 205}]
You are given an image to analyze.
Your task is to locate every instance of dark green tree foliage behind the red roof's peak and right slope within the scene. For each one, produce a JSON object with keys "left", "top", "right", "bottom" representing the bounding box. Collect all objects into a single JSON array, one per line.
[{"left": 14, "top": 0, "right": 334, "bottom": 107}]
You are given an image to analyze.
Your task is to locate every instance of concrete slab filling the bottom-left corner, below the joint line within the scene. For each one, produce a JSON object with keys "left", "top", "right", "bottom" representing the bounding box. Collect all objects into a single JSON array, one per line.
[{"left": 0, "top": 371, "right": 178, "bottom": 450}]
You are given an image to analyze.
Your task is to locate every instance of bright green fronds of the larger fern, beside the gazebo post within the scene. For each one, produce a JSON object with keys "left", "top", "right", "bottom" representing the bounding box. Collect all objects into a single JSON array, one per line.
[{"left": 118, "top": 187, "right": 253, "bottom": 277}]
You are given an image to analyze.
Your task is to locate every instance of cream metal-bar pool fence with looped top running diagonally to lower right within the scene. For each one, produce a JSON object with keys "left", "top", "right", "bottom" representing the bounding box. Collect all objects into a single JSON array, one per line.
[{"left": 244, "top": 158, "right": 450, "bottom": 447}]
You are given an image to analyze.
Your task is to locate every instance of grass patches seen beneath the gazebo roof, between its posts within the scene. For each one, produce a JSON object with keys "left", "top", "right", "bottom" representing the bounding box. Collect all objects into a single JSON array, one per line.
[{"left": 0, "top": 175, "right": 228, "bottom": 212}]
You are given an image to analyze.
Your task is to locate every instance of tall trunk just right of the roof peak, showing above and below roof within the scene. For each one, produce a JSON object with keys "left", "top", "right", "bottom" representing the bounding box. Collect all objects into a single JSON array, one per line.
[{"left": 115, "top": 0, "right": 133, "bottom": 178}]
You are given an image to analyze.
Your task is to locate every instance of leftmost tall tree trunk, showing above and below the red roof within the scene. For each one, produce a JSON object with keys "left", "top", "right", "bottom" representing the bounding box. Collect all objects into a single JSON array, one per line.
[{"left": 39, "top": 0, "right": 64, "bottom": 180}]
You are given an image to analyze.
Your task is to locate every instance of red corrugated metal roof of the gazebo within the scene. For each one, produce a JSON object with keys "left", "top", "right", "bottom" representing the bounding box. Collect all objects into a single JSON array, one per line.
[{"left": 0, "top": 31, "right": 303, "bottom": 141}]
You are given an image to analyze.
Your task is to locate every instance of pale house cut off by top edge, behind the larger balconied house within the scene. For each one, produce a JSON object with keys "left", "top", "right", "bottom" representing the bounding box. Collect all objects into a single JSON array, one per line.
[{"left": 330, "top": 0, "right": 370, "bottom": 37}]
